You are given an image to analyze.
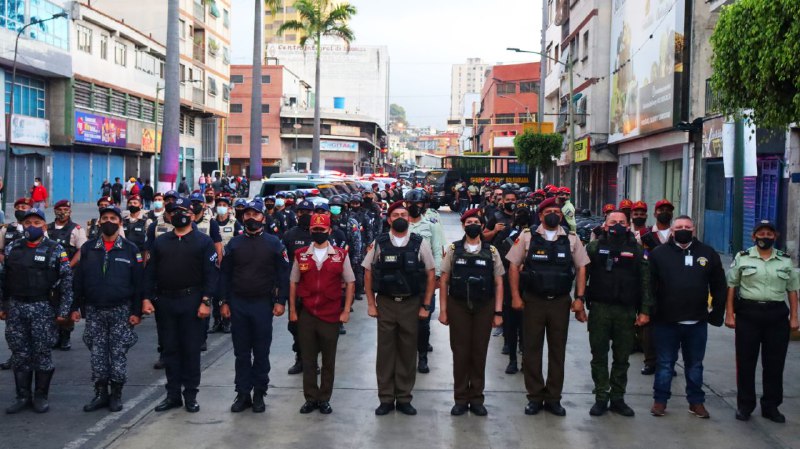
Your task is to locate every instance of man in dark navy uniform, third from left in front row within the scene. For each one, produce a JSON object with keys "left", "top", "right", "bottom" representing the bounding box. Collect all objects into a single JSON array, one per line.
[{"left": 142, "top": 198, "right": 219, "bottom": 413}]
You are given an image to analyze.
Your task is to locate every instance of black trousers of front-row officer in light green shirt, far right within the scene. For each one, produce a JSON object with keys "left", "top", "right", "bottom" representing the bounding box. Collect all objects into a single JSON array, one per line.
[{"left": 736, "top": 300, "right": 790, "bottom": 413}]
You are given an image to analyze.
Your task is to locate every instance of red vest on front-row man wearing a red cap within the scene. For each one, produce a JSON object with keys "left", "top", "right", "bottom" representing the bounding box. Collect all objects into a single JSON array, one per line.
[{"left": 294, "top": 246, "right": 347, "bottom": 323}]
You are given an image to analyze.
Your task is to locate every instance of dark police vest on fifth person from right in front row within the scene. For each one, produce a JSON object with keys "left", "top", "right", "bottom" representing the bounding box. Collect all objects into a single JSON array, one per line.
[{"left": 448, "top": 240, "right": 494, "bottom": 302}]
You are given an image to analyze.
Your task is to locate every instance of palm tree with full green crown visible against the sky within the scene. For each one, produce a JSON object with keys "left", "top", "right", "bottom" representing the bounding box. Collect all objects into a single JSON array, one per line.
[{"left": 277, "top": 0, "right": 357, "bottom": 173}]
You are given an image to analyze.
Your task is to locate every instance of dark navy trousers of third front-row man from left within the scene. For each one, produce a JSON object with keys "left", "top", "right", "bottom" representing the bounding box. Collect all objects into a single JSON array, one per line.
[{"left": 156, "top": 292, "right": 206, "bottom": 398}]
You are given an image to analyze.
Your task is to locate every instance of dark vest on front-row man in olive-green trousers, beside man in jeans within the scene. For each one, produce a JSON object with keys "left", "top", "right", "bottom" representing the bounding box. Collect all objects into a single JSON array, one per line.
[{"left": 587, "top": 237, "right": 642, "bottom": 306}]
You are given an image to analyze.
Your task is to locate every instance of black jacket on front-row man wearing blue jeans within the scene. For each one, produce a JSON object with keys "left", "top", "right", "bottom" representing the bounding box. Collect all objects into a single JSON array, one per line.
[{"left": 649, "top": 239, "right": 727, "bottom": 326}]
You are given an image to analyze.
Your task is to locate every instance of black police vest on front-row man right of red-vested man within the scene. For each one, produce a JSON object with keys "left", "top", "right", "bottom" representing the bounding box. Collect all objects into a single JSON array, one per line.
[{"left": 372, "top": 233, "right": 427, "bottom": 296}]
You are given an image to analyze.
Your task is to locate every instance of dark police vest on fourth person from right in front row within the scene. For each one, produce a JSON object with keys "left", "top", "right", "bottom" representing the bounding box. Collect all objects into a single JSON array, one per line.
[{"left": 522, "top": 232, "right": 575, "bottom": 297}]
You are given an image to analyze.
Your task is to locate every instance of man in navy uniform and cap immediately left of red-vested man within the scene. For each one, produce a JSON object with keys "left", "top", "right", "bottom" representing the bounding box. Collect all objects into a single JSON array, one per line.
[{"left": 222, "top": 201, "right": 289, "bottom": 413}]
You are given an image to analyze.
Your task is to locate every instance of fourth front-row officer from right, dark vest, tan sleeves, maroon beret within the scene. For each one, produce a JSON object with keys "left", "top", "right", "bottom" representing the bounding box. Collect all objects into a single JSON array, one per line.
[{"left": 506, "top": 197, "right": 589, "bottom": 416}]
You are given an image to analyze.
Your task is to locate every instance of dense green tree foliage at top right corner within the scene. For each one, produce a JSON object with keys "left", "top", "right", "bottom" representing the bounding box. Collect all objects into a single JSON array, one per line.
[{"left": 711, "top": 0, "right": 800, "bottom": 128}]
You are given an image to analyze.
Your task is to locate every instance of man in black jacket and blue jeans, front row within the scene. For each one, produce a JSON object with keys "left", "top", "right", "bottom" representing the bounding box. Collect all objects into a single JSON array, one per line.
[{"left": 648, "top": 215, "right": 726, "bottom": 418}]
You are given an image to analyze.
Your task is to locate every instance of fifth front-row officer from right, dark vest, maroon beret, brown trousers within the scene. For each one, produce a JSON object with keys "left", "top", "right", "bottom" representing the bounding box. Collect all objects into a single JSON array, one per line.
[{"left": 439, "top": 209, "right": 505, "bottom": 416}]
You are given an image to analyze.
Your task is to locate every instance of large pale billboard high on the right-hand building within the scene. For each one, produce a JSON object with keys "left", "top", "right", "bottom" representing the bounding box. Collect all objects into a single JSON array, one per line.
[{"left": 608, "top": 0, "right": 685, "bottom": 143}]
